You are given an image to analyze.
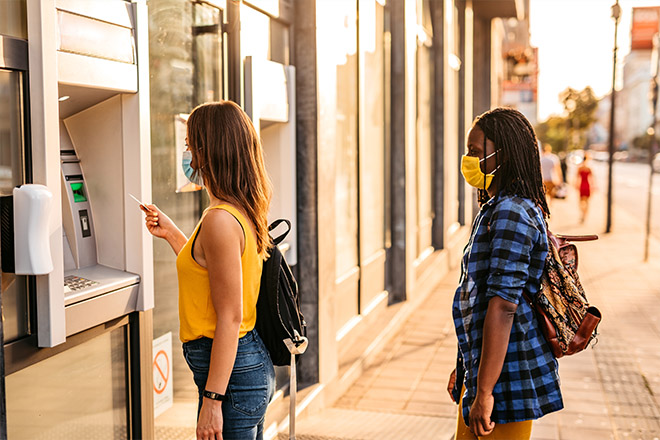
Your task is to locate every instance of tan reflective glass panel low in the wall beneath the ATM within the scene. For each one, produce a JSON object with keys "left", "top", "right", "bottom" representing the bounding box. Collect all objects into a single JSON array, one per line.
[{"left": 5, "top": 327, "right": 128, "bottom": 440}]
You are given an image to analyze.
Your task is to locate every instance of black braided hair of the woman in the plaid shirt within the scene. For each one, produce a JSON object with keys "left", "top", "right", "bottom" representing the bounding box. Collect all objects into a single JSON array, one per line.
[{"left": 472, "top": 107, "right": 550, "bottom": 217}]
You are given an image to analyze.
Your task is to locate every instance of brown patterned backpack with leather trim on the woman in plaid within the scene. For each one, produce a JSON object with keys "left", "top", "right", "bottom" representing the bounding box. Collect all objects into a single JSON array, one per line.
[{"left": 524, "top": 231, "right": 601, "bottom": 358}]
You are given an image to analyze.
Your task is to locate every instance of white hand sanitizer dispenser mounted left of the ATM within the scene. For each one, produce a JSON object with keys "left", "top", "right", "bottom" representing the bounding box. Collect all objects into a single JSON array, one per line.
[{"left": 13, "top": 184, "right": 53, "bottom": 275}]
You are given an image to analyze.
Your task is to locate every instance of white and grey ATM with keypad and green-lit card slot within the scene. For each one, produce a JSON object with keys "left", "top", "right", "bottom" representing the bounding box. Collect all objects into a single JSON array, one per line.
[{"left": 19, "top": 0, "right": 154, "bottom": 348}]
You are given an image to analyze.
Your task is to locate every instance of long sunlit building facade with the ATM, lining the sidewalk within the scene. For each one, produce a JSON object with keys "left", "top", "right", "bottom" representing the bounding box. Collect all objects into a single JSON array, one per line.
[{"left": 0, "top": 0, "right": 526, "bottom": 439}]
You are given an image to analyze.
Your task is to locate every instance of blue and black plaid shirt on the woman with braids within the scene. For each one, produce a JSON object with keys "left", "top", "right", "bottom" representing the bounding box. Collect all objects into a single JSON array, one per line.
[{"left": 452, "top": 195, "right": 564, "bottom": 423}]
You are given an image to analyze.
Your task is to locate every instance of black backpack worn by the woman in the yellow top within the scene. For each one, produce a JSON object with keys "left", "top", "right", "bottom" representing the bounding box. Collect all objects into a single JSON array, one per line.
[{"left": 255, "top": 219, "right": 307, "bottom": 366}]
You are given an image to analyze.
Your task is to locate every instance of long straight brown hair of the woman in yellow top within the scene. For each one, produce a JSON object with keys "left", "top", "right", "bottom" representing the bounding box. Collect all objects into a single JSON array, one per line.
[{"left": 188, "top": 101, "right": 272, "bottom": 255}]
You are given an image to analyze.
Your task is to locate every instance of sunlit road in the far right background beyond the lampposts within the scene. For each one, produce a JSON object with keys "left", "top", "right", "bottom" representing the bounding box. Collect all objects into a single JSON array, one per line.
[{"left": 568, "top": 161, "right": 660, "bottom": 238}]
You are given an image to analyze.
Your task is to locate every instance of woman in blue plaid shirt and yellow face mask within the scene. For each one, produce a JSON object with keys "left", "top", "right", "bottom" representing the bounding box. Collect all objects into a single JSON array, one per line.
[{"left": 448, "top": 108, "right": 563, "bottom": 440}]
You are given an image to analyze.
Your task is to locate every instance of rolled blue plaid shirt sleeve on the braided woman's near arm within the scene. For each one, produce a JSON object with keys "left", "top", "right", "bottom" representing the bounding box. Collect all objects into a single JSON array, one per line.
[{"left": 486, "top": 199, "right": 540, "bottom": 304}]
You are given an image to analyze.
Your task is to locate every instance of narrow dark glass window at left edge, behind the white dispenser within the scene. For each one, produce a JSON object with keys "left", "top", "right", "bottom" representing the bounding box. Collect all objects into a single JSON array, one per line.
[{"left": 0, "top": 69, "right": 30, "bottom": 343}]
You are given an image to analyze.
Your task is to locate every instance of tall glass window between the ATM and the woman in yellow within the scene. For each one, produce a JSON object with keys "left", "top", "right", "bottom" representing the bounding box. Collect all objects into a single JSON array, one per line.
[{"left": 148, "top": 0, "right": 224, "bottom": 438}]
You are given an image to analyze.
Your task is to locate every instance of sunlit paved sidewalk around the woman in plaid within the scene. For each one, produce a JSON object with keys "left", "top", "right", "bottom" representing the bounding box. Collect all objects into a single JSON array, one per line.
[{"left": 297, "top": 194, "right": 660, "bottom": 440}]
